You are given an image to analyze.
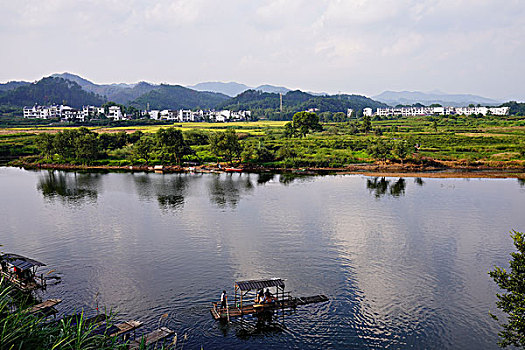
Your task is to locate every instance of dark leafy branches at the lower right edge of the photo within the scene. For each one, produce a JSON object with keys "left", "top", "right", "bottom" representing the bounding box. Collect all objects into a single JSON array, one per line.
[{"left": 489, "top": 231, "right": 525, "bottom": 348}]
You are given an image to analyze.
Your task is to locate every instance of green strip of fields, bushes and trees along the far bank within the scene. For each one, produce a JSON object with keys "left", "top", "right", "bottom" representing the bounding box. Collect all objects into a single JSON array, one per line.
[{"left": 0, "top": 112, "right": 525, "bottom": 171}]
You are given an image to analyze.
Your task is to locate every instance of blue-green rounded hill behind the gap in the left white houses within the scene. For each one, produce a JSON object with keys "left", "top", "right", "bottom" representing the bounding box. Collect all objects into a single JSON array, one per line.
[{"left": 129, "top": 84, "right": 229, "bottom": 109}]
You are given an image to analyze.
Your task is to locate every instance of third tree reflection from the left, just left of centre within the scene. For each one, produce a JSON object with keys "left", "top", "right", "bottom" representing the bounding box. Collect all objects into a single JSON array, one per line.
[{"left": 208, "top": 174, "right": 254, "bottom": 209}]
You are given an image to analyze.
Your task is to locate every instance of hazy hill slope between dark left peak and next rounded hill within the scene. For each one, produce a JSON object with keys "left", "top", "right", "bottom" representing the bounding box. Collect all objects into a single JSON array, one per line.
[{"left": 52, "top": 72, "right": 159, "bottom": 104}]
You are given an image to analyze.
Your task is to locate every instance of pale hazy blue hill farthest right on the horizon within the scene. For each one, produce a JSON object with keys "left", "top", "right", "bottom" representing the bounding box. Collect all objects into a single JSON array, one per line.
[{"left": 372, "top": 91, "right": 501, "bottom": 107}]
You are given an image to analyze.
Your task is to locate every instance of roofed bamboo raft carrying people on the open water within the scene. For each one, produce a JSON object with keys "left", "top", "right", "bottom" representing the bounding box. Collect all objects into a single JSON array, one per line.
[{"left": 210, "top": 279, "right": 329, "bottom": 320}]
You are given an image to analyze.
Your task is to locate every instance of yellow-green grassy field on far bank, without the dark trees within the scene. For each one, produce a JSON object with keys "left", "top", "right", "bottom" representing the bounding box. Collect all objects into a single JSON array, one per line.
[{"left": 0, "top": 116, "right": 525, "bottom": 167}]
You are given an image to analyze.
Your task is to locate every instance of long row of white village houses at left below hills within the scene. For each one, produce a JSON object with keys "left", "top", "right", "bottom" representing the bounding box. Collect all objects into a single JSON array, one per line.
[{"left": 24, "top": 105, "right": 251, "bottom": 122}]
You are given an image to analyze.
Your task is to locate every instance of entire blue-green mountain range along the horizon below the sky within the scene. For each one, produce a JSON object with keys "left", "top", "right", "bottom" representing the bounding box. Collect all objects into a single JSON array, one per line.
[{"left": 0, "top": 73, "right": 508, "bottom": 119}]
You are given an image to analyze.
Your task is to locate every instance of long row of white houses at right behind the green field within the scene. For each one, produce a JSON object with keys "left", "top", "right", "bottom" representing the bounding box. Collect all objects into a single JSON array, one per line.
[{"left": 363, "top": 107, "right": 510, "bottom": 117}]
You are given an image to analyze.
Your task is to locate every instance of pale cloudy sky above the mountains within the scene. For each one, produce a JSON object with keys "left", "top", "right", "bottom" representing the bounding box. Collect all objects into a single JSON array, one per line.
[{"left": 0, "top": 0, "right": 525, "bottom": 101}]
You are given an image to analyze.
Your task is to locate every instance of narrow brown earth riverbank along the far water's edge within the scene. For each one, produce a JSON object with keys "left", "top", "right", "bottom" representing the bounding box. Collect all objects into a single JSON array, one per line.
[{"left": 8, "top": 159, "right": 525, "bottom": 180}]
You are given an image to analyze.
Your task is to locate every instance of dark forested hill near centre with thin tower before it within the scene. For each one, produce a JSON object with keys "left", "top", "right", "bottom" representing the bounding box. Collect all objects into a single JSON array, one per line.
[{"left": 217, "top": 90, "right": 388, "bottom": 119}]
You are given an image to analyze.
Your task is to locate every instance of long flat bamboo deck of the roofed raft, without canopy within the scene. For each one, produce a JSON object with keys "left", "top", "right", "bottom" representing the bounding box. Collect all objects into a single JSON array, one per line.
[{"left": 210, "top": 295, "right": 328, "bottom": 320}]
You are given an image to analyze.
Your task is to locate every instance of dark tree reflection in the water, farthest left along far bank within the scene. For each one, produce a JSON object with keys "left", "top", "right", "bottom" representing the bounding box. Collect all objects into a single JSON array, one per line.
[{"left": 37, "top": 171, "right": 102, "bottom": 204}]
